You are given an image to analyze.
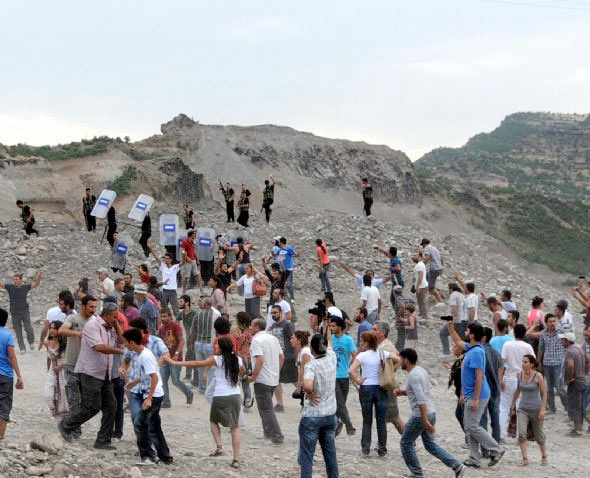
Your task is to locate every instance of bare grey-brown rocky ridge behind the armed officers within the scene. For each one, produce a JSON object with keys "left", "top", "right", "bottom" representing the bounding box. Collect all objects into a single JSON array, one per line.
[{"left": 0, "top": 114, "right": 420, "bottom": 226}]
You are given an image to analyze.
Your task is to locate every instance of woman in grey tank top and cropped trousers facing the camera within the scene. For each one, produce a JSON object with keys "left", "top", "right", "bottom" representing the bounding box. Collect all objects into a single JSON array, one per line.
[{"left": 511, "top": 355, "right": 548, "bottom": 466}]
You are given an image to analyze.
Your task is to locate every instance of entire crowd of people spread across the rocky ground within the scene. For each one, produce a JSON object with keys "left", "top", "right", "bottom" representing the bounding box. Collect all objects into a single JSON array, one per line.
[{"left": 0, "top": 183, "right": 590, "bottom": 478}]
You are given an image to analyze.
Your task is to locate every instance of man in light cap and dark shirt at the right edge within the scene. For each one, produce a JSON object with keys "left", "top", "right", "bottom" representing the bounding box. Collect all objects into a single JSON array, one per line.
[{"left": 559, "top": 332, "right": 590, "bottom": 437}]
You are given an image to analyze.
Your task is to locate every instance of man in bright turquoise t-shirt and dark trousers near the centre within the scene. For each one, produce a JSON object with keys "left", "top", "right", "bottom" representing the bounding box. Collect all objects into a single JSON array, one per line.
[{"left": 330, "top": 315, "right": 357, "bottom": 436}]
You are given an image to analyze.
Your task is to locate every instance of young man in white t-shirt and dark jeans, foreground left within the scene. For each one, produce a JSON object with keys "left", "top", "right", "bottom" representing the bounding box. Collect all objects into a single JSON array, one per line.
[{"left": 123, "top": 329, "right": 172, "bottom": 465}]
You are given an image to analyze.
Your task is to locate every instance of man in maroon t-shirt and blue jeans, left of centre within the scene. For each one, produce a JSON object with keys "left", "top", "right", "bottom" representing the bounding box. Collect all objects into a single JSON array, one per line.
[{"left": 158, "top": 309, "right": 193, "bottom": 408}]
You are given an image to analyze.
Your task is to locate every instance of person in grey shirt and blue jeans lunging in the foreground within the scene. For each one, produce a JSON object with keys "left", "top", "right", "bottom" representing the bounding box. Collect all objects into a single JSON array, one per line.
[{"left": 396, "top": 348, "right": 466, "bottom": 478}]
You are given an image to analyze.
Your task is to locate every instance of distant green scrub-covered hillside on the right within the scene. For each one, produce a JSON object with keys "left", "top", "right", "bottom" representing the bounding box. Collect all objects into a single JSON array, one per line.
[{"left": 416, "top": 113, "right": 590, "bottom": 274}]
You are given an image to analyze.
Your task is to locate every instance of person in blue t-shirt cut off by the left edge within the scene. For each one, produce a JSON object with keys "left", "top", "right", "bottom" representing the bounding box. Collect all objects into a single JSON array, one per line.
[{"left": 0, "top": 308, "right": 25, "bottom": 438}]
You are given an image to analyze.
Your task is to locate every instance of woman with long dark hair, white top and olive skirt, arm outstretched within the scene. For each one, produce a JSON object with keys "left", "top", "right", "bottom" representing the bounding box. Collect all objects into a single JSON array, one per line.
[{"left": 167, "top": 337, "right": 245, "bottom": 468}]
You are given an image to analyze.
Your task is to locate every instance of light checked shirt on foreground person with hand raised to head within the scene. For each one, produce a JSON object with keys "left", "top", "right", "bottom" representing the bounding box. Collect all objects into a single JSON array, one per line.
[{"left": 301, "top": 348, "right": 338, "bottom": 417}]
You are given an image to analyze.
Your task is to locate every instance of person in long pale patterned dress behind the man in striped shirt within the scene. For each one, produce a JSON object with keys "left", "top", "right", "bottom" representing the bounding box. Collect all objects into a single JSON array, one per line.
[{"left": 43, "top": 320, "right": 69, "bottom": 420}]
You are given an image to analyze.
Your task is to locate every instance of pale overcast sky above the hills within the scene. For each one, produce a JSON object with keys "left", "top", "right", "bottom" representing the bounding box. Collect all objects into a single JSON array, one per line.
[{"left": 0, "top": 0, "right": 590, "bottom": 159}]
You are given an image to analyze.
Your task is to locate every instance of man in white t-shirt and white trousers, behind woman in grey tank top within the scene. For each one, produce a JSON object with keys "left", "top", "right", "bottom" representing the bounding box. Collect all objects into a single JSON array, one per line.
[{"left": 499, "top": 324, "right": 535, "bottom": 439}]
